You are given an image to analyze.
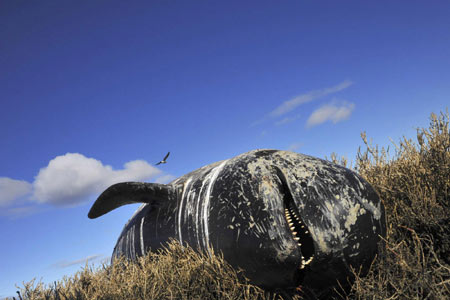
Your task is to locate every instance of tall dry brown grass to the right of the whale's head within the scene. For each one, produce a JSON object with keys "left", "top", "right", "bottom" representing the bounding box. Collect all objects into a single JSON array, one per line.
[{"left": 332, "top": 110, "right": 450, "bottom": 299}]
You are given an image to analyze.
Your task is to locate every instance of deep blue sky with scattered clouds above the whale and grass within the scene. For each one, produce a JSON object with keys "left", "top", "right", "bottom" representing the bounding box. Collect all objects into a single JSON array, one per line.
[{"left": 0, "top": 0, "right": 450, "bottom": 298}]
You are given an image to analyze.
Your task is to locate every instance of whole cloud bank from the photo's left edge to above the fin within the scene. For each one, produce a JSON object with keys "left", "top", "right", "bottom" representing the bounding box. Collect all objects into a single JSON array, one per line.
[{"left": 0, "top": 153, "right": 175, "bottom": 219}]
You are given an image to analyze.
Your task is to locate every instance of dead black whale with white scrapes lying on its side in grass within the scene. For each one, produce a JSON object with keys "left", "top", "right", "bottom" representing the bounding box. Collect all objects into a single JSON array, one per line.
[{"left": 88, "top": 150, "right": 386, "bottom": 295}]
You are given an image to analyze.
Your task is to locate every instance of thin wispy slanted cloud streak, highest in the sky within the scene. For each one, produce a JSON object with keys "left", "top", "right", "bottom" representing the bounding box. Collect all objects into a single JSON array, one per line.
[{"left": 269, "top": 80, "right": 353, "bottom": 118}]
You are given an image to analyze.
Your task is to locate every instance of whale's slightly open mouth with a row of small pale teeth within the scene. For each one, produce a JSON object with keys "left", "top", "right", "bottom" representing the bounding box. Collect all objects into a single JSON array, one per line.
[{"left": 277, "top": 170, "right": 314, "bottom": 270}]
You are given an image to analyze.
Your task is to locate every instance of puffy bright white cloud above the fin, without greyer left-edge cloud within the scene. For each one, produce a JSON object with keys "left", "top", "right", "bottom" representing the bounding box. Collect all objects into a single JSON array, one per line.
[{"left": 33, "top": 153, "right": 161, "bottom": 206}]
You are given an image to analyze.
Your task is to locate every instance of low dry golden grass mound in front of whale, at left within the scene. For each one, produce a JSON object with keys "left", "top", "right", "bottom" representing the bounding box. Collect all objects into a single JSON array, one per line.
[{"left": 10, "top": 241, "right": 294, "bottom": 300}]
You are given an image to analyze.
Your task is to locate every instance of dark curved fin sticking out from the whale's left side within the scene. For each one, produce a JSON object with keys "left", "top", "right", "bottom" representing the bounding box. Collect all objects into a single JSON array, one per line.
[{"left": 88, "top": 182, "right": 175, "bottom": 219}]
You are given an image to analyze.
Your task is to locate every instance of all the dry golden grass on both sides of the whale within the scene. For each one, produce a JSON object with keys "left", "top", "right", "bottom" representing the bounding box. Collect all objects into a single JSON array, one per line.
[{"left": 8, "top": 111, "right": 450, "bottom": 300}]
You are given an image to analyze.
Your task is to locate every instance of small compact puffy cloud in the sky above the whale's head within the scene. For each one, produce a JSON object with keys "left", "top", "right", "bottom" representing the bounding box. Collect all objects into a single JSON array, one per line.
[{"left": 306, "top": 102, "right": 355, "bottom": 128}]
